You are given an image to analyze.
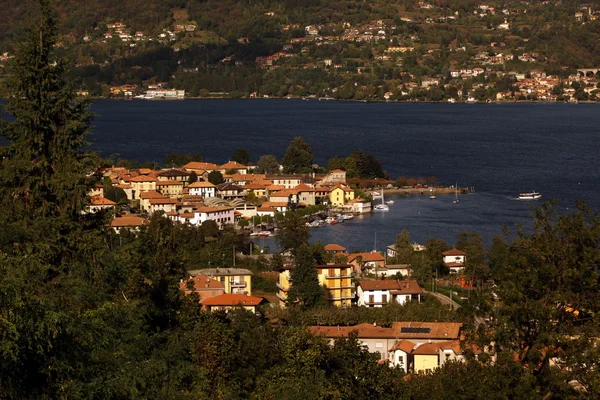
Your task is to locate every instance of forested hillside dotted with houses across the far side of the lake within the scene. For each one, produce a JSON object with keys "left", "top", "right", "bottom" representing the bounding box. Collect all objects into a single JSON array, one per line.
[{"left": 0, "top": 0, "right": 600, "bottom": 101}]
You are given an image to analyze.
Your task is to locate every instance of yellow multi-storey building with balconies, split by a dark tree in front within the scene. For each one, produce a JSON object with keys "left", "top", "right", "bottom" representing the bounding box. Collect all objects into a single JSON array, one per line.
[{"left": 277, "top": 264, "right": 354, "bottom": 307}]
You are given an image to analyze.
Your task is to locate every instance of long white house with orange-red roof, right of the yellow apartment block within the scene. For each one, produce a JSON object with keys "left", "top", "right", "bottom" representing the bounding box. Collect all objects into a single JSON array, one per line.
[{"left": 356, "top": 280, "right": 423, "bottom": 307}]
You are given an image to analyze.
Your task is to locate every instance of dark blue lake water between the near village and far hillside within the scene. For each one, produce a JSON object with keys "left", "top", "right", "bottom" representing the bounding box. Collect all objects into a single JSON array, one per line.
[{"left": 90, "top": 100, "right": 600, "bottom": 251}]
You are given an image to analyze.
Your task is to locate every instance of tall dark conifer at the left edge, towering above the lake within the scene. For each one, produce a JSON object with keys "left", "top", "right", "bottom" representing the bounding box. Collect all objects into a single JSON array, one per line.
[{"left": 0, "top": 0, "right": 93, "bottom": 223}]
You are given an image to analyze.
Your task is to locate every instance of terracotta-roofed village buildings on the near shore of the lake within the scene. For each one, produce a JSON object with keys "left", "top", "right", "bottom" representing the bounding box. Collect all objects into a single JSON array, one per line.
[{"left": 88, "top": 157, "right": 492, "bottom": 373}]
